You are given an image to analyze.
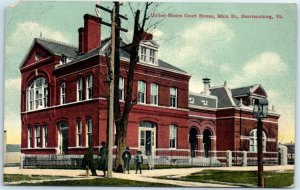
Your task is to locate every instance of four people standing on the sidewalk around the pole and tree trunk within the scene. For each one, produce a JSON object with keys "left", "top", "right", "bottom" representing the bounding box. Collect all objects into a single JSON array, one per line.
[{"left": 82, "top": 142, "right": 143, "bottom": 176}]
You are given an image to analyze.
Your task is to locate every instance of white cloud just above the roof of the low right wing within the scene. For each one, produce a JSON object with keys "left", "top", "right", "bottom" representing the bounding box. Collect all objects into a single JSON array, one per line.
[{"left": 230, "top": 51, "right": 287, "bottom": 85}]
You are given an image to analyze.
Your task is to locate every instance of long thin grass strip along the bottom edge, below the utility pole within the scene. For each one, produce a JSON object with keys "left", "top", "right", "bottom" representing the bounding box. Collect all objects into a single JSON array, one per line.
[{"left": 20, "top": 178, "right": 176, "bottom": 187}]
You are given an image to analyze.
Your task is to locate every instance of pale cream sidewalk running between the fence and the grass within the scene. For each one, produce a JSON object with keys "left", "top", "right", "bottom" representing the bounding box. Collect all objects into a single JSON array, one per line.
[{"left": 4, "top": 165, "right": 294, "bottom": 188}]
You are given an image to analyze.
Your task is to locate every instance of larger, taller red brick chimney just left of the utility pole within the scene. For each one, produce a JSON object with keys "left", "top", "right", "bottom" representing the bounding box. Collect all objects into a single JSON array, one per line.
[{"left": 83, "top": 14, "right": 101, "bottom": 53}]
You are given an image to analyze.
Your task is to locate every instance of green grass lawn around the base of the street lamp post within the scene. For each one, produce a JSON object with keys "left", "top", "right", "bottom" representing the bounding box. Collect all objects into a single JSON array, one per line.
[{"left": 158, "top": 170, "right": 294, "bottom": 188}]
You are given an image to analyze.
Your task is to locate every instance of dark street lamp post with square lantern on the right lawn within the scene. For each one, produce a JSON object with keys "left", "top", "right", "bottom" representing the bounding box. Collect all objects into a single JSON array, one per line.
[{"left": 253, "top": 99, "right": 268, "bottom": 187}]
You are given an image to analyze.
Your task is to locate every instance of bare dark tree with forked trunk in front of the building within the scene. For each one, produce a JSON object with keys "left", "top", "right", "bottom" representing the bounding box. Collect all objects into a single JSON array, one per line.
[{"left": 114, "top": 2, "right": 157, "bottom": 172}]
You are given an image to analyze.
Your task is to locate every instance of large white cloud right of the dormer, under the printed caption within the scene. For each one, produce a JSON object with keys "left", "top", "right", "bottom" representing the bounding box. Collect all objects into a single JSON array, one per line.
[{"left": 164, "top": 20, "right": 235, "bottom": 66}]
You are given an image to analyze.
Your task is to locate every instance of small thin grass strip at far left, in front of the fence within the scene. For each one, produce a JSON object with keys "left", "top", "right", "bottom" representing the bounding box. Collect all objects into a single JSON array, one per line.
[{"left": 3, "top": 174, "right": 73, "bottom": 182}]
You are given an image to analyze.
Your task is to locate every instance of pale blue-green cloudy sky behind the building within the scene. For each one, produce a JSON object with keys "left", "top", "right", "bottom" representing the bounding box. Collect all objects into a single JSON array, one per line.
[{"left": 4, "top": 1, "right": 297, "bottom": 143}]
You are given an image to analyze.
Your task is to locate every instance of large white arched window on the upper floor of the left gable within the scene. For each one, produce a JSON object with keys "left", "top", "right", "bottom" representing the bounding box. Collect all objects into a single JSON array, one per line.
[{"left": 27, "top": 77, "right": 48, "bottom": 111}]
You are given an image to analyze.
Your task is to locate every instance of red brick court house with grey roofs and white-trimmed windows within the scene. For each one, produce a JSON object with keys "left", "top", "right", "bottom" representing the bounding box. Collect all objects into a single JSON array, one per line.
[{"left": 20, "top": 15, "right": 279, "bottom": 157}]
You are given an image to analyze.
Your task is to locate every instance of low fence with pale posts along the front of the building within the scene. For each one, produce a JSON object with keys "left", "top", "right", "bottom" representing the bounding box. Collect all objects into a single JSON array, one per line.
[{"left": 20, "top": 150, "right": 278, "bottom": 169}]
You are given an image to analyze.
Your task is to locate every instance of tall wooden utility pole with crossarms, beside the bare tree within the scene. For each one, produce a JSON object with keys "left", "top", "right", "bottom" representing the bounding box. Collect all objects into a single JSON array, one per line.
[{"left": 96, "top": 4, "right": 127, "bottom": 178}]
